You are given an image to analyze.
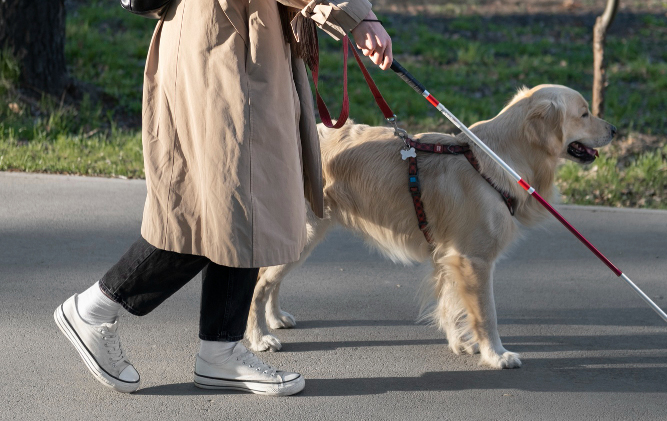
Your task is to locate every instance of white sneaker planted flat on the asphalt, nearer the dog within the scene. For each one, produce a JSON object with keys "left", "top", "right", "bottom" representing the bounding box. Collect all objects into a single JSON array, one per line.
[{"left": 195, "top": 342, "right": 306, "bottom": 396}]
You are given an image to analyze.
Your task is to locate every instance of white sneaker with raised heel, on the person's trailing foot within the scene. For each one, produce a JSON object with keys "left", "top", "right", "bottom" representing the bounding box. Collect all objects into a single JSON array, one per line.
[{"left": 53, "top": 294, "right": 141, "bottom": 393}]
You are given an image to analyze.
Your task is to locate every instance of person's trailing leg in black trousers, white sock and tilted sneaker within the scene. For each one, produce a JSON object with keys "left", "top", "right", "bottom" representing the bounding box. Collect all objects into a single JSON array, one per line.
[{"left": 54, "top": 238, "right": 208, "bottom": 392}]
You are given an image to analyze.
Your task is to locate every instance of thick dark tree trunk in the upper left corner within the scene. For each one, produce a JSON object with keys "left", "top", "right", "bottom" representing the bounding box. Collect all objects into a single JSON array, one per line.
[{"left": 0, "top": 0, "right": 67, "bottom": 95}]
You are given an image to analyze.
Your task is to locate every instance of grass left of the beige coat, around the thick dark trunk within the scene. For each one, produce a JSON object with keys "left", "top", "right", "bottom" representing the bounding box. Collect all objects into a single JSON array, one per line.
[{"left": 0, "top": 1, "right": 155, "bottom": 178}]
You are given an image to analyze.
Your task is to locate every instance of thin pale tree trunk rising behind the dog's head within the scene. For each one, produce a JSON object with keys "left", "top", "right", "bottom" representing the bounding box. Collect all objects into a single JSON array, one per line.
[{"left": 592, "top": 0, "right": 618, "bottom": 118}]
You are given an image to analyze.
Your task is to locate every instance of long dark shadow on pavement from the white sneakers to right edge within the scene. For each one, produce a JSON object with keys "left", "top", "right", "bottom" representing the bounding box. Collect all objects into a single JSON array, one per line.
[{"left": 136, "top": 358, "right": 667, "bottom": 397}]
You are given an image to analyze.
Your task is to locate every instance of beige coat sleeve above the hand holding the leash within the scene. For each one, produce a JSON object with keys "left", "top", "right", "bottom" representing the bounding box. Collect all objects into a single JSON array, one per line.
[{"left": 278, "top": 0, "right": 371, "bottom": 40}]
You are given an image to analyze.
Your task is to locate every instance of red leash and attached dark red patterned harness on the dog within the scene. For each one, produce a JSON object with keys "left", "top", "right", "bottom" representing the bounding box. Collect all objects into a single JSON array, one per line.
[{"left": 311, "top": 36, "right": 515, "bottom": 245}]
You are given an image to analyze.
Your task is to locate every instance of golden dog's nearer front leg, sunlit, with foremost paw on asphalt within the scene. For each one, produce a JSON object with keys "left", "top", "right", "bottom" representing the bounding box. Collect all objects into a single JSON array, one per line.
[{"left": 455, "top": 256, "right": 521, "bottom": 368}]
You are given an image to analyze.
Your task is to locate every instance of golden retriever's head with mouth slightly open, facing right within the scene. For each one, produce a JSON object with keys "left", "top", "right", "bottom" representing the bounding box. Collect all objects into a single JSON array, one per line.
[{"left": 510, "top": 85, "right": 616, "bottom": 164}]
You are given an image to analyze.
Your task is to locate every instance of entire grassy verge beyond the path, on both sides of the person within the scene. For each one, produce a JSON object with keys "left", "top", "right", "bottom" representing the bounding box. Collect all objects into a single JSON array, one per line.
[{"left": 0, "top": 1, "right": 667, "bottom": 208}]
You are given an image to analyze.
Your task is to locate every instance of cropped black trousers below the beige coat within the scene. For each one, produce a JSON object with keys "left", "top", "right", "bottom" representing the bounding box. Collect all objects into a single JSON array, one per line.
[{"left": 100, "top": 238, "right": 259, "bottom": 342}]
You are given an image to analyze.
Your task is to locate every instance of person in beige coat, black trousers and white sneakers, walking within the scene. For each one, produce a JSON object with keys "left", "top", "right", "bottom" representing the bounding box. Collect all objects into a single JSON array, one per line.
[{"left": 54, "top": 0, "right": 392, "bottom": 396}]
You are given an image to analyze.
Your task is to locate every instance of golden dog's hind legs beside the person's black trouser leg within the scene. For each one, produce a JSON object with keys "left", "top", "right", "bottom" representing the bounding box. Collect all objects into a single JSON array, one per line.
[{"left": 245, "top": 206, "right": 332, "bottom": 352}]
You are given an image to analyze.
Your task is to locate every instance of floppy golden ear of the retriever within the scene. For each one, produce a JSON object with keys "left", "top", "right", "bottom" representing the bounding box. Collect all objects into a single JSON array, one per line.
[{"left": 524, "top": 97, "right": 565, "bottom": 153}]
